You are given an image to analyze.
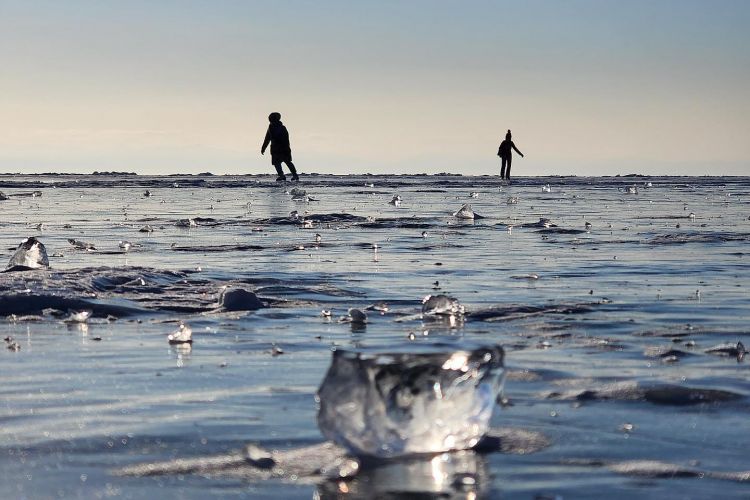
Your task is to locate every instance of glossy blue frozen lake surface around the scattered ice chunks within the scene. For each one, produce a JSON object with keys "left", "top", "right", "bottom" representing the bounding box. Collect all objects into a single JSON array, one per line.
[{"left": 0, "top": 176, "right": 750, "bottom": 498}]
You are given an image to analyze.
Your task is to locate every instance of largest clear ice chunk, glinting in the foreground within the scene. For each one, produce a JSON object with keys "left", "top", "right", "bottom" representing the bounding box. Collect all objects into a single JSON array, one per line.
[{"left": 318, "top": 342, "right": 504, "bottom": 458}]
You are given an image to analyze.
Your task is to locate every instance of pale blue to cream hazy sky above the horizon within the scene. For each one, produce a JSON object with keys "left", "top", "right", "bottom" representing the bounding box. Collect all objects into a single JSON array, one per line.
[{"left": 0, "top": 0, "right": 750, "bottom": 176}]
